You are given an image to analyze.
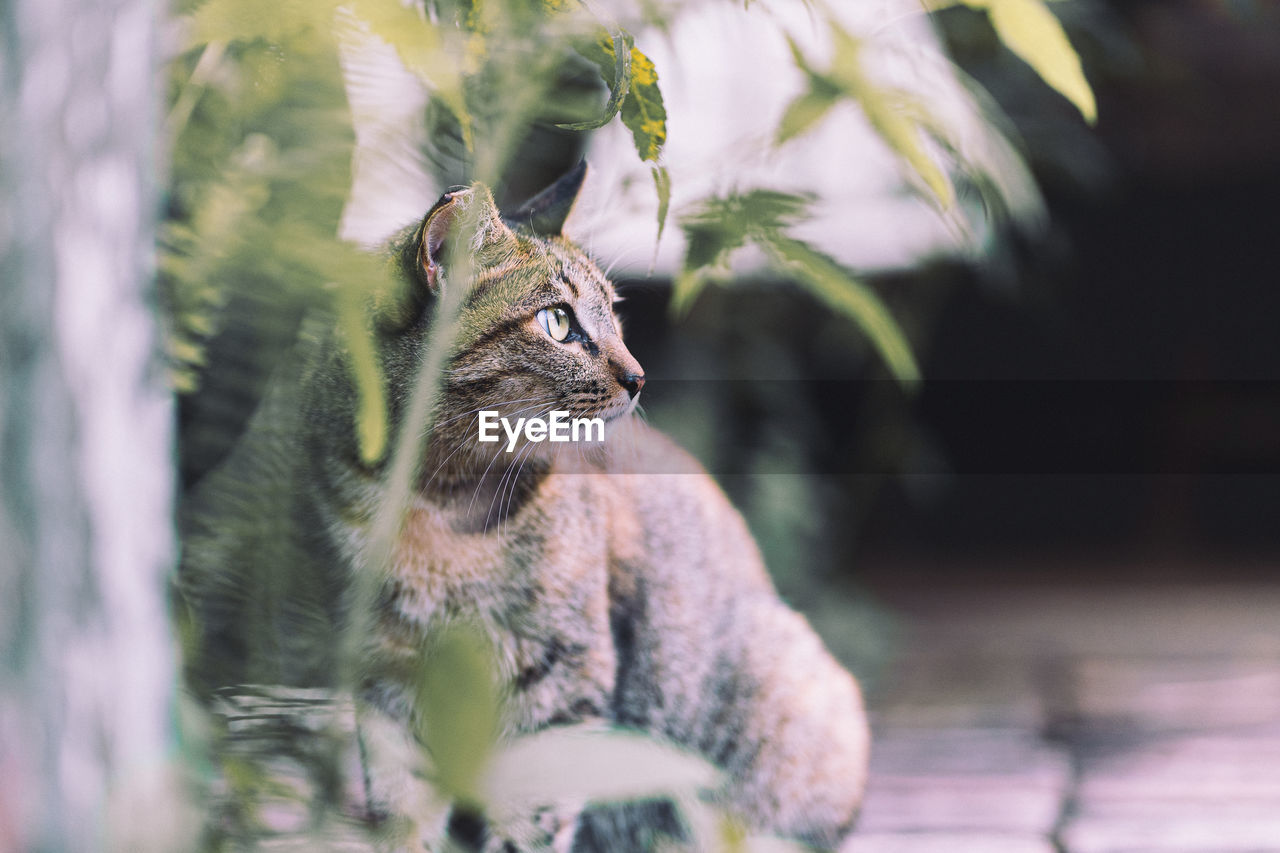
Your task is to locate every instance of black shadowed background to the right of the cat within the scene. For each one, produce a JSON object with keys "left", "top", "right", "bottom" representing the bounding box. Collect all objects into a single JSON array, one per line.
[{"left": 623, "top": 0, "right": 1280, "bottom": 585}]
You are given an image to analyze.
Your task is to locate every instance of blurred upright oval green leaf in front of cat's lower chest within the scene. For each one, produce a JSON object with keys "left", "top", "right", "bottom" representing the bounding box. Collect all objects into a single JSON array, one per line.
[{"left": 416, "top": 626, "right": 499, "bottom": 806}]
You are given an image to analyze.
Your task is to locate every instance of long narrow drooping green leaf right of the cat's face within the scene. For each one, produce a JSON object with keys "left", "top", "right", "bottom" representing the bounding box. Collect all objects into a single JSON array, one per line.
[{"left": 763, "top": 236, "right": 920, "bottom": 388}]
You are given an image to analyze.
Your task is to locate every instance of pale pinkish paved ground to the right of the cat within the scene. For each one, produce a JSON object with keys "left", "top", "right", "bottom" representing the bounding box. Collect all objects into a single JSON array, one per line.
[{"left": 849, "top": 583, "right": 1280, "bottom": 853}]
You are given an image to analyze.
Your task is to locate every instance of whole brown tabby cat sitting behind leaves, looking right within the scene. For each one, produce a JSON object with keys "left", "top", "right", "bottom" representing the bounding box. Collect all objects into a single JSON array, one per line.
[{"left": 183, "top": 174, "right": 868, "bottom": 852}]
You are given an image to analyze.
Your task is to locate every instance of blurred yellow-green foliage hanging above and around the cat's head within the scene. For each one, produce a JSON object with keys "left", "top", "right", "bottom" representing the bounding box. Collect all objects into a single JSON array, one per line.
[{"left": 160, "top": 0, "right": 1094, "bottom": 461}]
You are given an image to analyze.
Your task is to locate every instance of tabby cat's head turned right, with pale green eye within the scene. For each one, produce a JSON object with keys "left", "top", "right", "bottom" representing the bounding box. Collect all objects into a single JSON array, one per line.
[{"left": 373, "top": 168, "right": 644, "bottom": 484}]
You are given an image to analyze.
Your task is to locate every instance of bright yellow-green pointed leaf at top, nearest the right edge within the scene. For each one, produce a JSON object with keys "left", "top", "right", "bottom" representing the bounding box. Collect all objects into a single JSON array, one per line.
[{"left": 964, "top": 0, "right": 1098, "bottom": 124}]
